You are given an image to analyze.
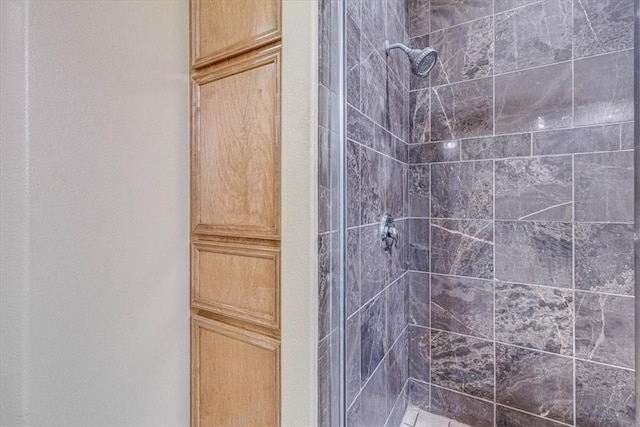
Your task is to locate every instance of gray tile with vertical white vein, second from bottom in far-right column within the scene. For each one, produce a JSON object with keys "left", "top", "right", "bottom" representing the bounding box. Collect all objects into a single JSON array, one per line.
[{"left": 576, "top": 291, "right": 634, "bottom": 368}]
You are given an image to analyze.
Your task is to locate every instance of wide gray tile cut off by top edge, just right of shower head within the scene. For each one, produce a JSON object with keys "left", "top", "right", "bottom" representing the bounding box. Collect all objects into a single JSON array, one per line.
[{"left": 431, "top": 0, "right": 493, "bottom": 32}]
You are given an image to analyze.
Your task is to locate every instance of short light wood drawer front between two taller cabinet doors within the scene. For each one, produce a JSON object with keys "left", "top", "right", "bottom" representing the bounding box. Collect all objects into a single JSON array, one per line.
[{"left": 191, "top": 241, "right": 280, "bottom": 329}]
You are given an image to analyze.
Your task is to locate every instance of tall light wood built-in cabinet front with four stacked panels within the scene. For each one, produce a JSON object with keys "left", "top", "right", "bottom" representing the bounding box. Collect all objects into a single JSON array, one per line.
[{"left": 191, "top": 0, "right": 281, "bottom": 426}]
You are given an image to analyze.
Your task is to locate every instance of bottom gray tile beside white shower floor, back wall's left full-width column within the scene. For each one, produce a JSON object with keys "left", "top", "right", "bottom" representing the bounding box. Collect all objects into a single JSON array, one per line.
[{"left": 429, "top": 386, "right": 494, "bottom": 427}]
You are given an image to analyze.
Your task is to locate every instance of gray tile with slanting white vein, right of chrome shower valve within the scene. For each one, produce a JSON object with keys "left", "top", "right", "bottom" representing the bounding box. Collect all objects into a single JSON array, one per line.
[{"left": 431, "top": 219, "right": 493, "bottom": 279}]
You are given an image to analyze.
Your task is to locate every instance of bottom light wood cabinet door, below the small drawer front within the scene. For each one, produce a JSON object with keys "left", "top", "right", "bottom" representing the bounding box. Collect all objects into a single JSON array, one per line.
[{"left": 191, "top": 316, "right": 280, "bottom": 427}]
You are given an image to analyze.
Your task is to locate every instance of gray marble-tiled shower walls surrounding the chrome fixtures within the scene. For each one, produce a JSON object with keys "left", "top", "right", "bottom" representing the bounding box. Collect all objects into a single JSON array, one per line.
[{"left": 318, "top": 0, "right": 635, "bottom": 427}]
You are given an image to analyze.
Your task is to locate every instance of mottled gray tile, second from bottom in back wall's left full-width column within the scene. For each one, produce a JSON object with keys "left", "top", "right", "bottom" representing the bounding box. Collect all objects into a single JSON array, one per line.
[{"left": 431, "top": 331, "right": 494, "bottom": 399}]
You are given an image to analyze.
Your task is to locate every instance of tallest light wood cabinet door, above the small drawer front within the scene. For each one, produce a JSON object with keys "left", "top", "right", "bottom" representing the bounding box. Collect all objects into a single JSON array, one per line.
[{"left": 191, "top": 46, "right": 280, "bottom": 240}]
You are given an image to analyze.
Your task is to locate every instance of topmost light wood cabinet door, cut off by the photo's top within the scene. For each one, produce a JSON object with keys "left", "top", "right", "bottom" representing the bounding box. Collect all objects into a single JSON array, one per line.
[{"left": 191, "top": 0, "right": 282, "bottom": 68}]
